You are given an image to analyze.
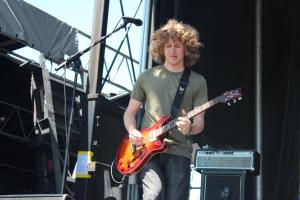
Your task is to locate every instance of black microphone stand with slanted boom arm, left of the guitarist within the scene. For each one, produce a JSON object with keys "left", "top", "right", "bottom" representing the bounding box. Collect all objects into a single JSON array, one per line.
[{"left": 55, "top": 21, "right": 129, "bottom": 194}]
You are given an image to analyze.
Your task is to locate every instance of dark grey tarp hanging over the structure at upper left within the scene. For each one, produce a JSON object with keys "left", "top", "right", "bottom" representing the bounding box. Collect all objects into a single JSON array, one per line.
[{"left": 0, "top": 0, "right": 78, "bottom": 60}]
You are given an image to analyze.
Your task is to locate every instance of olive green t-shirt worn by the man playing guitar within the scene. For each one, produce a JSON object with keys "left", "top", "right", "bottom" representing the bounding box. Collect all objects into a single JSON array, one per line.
[{"left": 131, "top": 66, "right": 207, "bottom": 158}]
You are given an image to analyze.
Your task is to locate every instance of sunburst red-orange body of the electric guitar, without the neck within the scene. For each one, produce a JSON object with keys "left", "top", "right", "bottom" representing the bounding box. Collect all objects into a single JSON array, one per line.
[{"left": 116, "top": 116, "right": 172, "bottom": 175}]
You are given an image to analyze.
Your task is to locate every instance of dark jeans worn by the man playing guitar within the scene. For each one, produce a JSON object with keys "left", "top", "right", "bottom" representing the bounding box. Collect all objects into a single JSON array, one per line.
[{"left": 139, "top": 153, "right": 190, "bottom": 200}]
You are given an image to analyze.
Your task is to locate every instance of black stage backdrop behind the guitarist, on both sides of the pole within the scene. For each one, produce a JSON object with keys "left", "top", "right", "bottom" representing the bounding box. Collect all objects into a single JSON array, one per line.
[{"left": 155, "top": 0, "right": 300, "bottom": 200}]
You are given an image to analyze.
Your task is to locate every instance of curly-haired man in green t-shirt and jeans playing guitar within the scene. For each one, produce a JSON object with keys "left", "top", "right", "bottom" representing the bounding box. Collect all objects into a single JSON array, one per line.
[{"left": 124, "top": 20, "right": 207, "bottom": 200}]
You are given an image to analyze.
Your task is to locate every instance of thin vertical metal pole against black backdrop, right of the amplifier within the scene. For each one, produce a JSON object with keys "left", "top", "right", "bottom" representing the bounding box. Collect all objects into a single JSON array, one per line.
[{"left": 255, "top": 0, "right": 263, "bottom": 200}]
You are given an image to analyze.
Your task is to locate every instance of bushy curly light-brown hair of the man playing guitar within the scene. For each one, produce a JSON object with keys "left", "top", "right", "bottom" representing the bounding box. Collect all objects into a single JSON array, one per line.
[{"left": 149, "top": 19, "right": 203, "bottom": 67}]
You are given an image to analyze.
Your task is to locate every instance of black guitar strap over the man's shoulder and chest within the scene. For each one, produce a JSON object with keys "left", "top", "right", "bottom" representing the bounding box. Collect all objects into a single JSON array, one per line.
[{"left": 171, "top": 68, "right": 191, "bottom": 118}]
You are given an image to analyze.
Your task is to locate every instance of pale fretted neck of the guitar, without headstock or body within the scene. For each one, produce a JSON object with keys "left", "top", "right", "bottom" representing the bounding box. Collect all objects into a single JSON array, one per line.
[{"left": 155, "top": 98, "right": 218, "bottom": 137}]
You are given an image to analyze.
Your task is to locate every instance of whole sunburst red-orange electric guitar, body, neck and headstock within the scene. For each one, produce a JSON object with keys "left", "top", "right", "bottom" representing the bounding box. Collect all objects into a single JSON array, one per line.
[{"left": 116, "top": 88, "right": 242, "bottom": 175}]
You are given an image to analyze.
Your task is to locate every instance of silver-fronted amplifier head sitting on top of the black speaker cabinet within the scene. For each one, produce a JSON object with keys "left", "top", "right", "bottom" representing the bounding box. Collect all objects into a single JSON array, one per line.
[{"left": 194, "top": 149, "right": 260, "bottom": 174}]
